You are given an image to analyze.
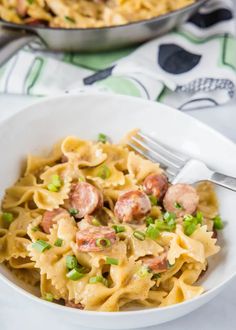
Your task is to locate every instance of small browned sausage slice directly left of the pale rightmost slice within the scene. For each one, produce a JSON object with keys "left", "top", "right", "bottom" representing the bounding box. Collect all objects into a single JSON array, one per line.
[{"left": 143, "top": 174, "right": 168, "bottom": 199}]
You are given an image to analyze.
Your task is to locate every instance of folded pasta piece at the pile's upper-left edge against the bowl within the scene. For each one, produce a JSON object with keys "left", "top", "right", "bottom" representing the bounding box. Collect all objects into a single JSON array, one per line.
[{"left": 24, "top": 143, "right": 62, "bottom": 176}]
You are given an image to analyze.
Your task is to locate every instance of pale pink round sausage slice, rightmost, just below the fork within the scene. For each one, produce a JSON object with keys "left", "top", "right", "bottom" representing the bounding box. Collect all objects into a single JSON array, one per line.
[{"left": 163, "top": 183, "right": 199, "bottom": 217}]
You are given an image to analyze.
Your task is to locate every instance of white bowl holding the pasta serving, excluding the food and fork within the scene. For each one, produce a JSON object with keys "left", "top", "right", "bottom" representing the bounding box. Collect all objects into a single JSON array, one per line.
[{"left": 0, "top": 94, "right": 236, "bottom": 329}]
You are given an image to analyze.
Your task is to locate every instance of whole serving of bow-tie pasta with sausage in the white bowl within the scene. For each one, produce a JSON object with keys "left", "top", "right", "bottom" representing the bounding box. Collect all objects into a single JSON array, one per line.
[{"left": 0, "top": 134, "right": 223, "bottom": 312}]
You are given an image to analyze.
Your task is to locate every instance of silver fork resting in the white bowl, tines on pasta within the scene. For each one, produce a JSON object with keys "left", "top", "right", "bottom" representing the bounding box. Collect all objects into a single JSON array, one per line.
[{"left": 128, "top": 131, "right": 236, "bottom": 191}]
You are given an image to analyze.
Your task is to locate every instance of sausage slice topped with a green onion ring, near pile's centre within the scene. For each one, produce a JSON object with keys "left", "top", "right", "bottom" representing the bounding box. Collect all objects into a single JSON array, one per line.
[{"left": 76, "top": 226, "right": 116, "bottom": 252}]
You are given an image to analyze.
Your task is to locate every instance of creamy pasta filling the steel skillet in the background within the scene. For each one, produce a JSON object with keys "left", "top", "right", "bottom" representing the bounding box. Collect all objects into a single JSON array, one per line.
[{"left": 0, "top": 0, "right": 195, "bottom": 29}]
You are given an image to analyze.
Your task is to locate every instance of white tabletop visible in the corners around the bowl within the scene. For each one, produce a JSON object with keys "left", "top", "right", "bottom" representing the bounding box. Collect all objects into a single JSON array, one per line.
[{"left": 0, "top": 96, "right": 236, "bottom": 330}]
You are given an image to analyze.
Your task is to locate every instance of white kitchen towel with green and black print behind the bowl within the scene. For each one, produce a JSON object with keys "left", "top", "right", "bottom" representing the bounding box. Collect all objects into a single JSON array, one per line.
[{"left": 0, "top": 0, "right": 236, "bottom": 110}]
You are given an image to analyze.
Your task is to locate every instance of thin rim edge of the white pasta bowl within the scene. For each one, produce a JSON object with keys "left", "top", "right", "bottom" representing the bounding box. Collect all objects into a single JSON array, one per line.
[{"left": 0, "top": 91, "right": 236, "bottom": 317}]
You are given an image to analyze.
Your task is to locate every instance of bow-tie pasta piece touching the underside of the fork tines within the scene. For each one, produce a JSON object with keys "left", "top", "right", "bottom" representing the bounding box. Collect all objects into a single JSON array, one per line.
[{"left": 127, "top": 151, "right": 163, "bottom": 182}]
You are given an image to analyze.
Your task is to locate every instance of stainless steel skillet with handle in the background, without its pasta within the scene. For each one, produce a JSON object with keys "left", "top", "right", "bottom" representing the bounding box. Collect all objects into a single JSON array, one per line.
[{"left": 0, "top": 0, "right": 207, "bottom": 66}]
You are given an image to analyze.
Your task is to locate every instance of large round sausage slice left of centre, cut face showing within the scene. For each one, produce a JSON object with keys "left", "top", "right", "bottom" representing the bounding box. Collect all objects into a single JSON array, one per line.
[{"left": 69, "top": 182, "right": 103, "bottom": 219}]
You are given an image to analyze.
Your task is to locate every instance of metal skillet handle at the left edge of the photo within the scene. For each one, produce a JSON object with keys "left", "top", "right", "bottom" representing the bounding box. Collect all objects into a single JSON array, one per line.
[{"left": 0, "top": 28, "right": 38, "bottom": 67}]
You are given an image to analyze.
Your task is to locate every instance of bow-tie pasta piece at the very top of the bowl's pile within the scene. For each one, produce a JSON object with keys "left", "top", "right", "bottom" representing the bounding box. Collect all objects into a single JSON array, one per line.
[{"left": 61, "top": 136, "right": 107, "bottom": 167}]
